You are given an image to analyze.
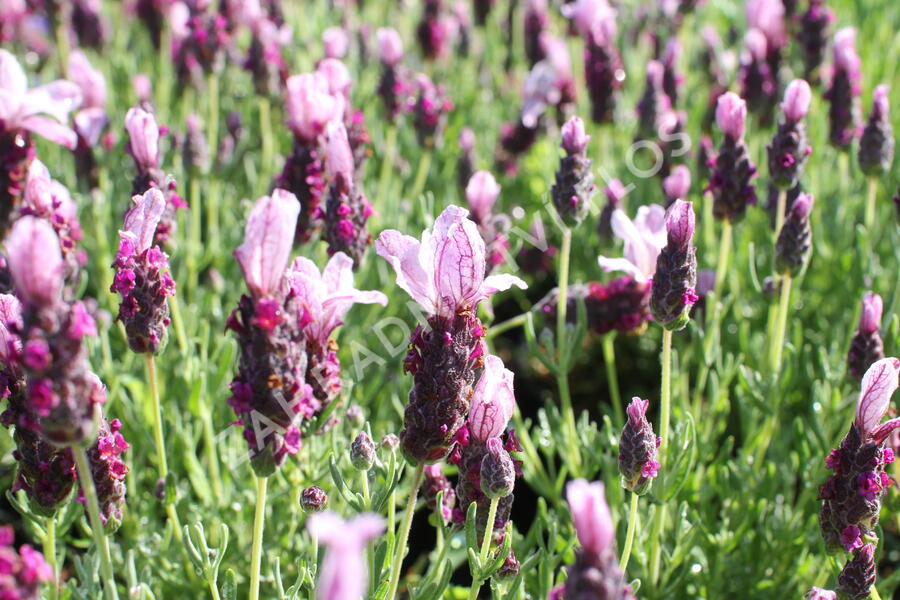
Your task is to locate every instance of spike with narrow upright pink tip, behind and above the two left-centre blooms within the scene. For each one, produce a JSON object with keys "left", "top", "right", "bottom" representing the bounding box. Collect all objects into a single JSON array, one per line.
[{"left": 323, "top": 121, "right": 374, "bottom": 267}]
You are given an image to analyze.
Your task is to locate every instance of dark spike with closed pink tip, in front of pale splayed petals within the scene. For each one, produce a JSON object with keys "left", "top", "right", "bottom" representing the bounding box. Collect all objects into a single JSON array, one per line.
[{"left": 650, "top": 200, "right": 698, "bottom": 331}]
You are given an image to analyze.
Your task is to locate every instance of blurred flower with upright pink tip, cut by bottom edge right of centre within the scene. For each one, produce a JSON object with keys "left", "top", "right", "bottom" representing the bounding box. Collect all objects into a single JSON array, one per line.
[{"left": 565, "top": 479, "right": 634, "bottom": 600}]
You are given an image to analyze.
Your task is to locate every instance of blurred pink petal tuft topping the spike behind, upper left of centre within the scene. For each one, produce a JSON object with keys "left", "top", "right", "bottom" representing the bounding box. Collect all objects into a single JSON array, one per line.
[{"left": 285, "top": 71, "right": 345, "bottom": 142}]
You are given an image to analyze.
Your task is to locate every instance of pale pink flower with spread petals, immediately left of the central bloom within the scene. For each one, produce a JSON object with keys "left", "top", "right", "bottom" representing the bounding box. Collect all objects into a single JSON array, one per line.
[{"left": 286, "top": 252, "right": 387, "bottom": 408}]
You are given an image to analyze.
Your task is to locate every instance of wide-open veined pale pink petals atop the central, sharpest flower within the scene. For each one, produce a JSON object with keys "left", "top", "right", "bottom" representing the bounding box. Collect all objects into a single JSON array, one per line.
[{"left": 375, "top": 206, "right": 527, "bottom": 319}]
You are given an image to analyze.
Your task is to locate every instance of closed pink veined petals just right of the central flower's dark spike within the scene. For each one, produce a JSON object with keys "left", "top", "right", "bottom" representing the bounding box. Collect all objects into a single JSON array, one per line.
[{"left": 468, "top": 355, "right": 516, "bottom": 444}]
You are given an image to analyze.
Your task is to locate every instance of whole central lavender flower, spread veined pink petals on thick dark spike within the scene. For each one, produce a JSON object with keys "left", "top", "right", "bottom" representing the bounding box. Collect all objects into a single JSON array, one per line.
[{"left": 375, "top": 206, "right": 526, "bottom": 464}]
